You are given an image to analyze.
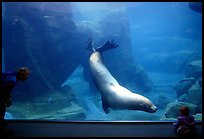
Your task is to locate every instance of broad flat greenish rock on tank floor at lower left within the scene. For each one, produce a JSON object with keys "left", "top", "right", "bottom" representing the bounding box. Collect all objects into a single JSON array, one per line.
[{"left": 7, "top": 93, "right": 86, "bottom": 120}]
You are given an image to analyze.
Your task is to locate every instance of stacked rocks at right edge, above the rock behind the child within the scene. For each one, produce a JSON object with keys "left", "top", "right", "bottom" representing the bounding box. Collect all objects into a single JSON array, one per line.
[{"left": 174, "top": 60, "right": 202, "bottom": 112}]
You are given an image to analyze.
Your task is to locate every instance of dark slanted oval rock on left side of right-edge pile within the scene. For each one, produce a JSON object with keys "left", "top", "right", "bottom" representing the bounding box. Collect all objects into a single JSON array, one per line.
[{"left": 174, "top": 77, "right": 196, "bottom": 97}]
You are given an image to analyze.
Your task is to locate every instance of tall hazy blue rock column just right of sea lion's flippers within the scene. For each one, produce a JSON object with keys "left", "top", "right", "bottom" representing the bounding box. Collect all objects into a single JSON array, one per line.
[{"left": 101, "top": 10, "right": 152, "bottom": 92}]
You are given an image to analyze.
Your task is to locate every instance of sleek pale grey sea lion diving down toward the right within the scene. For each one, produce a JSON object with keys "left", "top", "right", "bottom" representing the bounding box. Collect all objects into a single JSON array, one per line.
[{"left": 86, "top": 39, "right": 157, "bottom": 114}]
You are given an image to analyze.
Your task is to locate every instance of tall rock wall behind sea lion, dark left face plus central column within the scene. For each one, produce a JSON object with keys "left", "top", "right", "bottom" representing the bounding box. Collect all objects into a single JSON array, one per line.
[{"left": 2, "top": 2, "right": 152, "bottom": 102}]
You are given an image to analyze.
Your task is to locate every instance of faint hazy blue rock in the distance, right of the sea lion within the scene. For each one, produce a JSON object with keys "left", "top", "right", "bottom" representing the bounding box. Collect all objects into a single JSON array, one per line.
[{"left": 141, "top": 48, "right": 198, "bottom": 73}]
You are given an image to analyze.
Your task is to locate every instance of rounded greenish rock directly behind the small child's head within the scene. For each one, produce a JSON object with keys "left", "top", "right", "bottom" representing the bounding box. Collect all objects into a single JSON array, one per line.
[{"left": 165, "top": 102, "right": 198, "bottom": 118}]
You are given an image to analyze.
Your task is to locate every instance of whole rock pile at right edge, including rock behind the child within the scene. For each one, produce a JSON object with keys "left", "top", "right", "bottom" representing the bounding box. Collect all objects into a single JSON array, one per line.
[{"left": 165, "top": 60, "right": 202, "bottom": 118}]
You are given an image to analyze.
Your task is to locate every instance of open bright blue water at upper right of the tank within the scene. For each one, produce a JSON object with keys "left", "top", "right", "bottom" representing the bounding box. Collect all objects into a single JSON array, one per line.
[{"left": 127, "top": 2, "right": 202, "bottom": 71}]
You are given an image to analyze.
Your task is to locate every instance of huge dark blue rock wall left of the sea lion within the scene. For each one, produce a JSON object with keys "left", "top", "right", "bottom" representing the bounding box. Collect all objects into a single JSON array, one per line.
[{"left": 2, "top": 2, "right": 89, "bottom": 99}]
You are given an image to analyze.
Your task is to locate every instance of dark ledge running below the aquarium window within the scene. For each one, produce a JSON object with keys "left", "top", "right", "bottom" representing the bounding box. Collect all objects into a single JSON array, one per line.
[{"left": 1, "top": 120, "right": 202, "bottom": 137}]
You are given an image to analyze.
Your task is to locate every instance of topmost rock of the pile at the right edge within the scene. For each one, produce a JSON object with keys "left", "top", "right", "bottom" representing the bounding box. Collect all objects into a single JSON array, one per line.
[{"left": 186, "top": 60, "right": 202, "bottom": 79}]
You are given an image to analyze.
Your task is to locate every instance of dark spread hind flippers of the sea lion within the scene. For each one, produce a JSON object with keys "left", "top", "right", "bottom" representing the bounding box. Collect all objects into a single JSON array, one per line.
[{"left": 84, "top": 38, "right": 118, "bottom": 53}]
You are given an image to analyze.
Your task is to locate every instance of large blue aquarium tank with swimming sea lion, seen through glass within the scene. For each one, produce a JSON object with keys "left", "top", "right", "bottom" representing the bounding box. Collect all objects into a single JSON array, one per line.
[{"left": 2, "top": 2, "right": 202, "bottom": 121}]
